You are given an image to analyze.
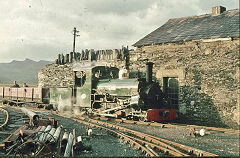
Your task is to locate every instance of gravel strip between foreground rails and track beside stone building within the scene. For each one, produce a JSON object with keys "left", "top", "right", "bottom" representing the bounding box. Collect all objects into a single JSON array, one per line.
[{"left": 113, "top": 123, "right": 239, "bottom": 156}]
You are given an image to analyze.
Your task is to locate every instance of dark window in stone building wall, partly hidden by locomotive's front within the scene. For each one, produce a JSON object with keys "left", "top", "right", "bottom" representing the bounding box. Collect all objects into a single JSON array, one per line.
[{"left": 163, "top": 77, "right": 179, "bottom": 109}]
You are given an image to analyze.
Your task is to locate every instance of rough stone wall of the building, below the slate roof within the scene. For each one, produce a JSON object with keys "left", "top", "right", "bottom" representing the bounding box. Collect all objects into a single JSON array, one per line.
[{"left": 130, "top": 39, "right": 240, "bottom": 127}]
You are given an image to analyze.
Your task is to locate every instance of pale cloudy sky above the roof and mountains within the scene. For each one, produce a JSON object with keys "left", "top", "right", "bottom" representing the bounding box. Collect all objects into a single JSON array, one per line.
[{"left": 0, "top": 0, "right": 239, "bottom": 63}]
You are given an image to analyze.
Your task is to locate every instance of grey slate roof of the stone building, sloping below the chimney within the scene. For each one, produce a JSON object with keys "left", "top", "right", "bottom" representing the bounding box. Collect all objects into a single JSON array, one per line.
[{"left": 133, "top": 9, "right": 239, "bottom": 47}]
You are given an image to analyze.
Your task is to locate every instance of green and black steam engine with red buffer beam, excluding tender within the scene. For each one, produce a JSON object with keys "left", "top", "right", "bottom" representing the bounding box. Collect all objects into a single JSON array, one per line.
[{"left": 78, "top": 63, "right": 176, "bottom": 121}]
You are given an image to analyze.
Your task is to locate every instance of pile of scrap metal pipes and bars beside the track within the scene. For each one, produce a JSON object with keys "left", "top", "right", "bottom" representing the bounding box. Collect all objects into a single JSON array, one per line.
[{"left": 2, "top": 108, "right": 91, "bottom": 157}]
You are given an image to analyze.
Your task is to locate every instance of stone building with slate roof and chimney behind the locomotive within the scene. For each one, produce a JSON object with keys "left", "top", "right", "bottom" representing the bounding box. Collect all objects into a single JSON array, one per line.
[{"left": 130, "top": 6, "right": 240, "bottom": 127}]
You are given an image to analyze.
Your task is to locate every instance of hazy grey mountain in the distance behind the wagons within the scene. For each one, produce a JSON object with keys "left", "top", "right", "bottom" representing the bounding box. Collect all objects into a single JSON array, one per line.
[{"left": 0, "top": 59, "right": 53, "bottom": 83}]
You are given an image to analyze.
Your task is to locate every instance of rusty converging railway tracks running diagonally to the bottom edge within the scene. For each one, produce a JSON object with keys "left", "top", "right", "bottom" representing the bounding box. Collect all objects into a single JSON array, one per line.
[{"left": 73, "top": 117, "right": 218, "bottom": 156}]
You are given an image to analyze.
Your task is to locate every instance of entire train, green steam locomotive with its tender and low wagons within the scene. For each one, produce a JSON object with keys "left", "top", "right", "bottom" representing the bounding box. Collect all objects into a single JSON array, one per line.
[{"left": 0, "top": 62, "right": 176, "bottom": 121}]
